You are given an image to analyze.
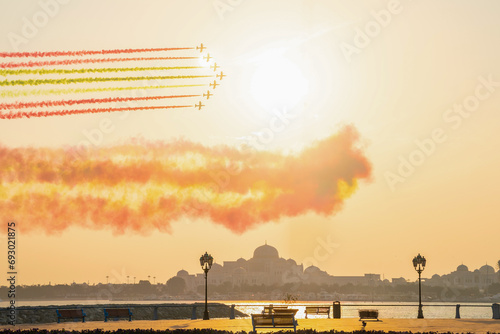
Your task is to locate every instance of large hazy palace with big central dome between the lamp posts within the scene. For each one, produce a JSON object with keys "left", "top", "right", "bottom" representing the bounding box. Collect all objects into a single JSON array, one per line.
[{"left": 168, "top": 243, "right": 381, "bottom": 291}]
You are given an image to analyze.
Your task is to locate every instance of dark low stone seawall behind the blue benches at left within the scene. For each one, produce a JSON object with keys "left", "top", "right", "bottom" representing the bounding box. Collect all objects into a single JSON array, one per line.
[{"left": 0, "top": 303, "right": 247, "bottom": 325}]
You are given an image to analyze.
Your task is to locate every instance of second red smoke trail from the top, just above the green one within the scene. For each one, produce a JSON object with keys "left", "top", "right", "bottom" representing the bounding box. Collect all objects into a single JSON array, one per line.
[{"left": 0, "top": 57, "right": 199, "bottom": 68}]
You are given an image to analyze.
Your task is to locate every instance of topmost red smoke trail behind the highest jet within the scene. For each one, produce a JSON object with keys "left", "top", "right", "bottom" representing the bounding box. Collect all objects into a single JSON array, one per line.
[{"left": 0, "top": 48, "right": 194, "bottom": 58}]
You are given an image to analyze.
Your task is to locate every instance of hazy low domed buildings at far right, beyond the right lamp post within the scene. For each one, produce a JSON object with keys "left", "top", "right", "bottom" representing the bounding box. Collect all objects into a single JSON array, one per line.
[{"left": 425, "top": 264, "right": 500, "bottom": 289}]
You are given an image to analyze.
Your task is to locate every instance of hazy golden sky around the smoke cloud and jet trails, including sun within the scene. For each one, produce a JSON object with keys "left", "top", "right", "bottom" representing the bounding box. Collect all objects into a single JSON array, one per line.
[{"left": 0, "top": 0, "right": 500, "bottom": 284}]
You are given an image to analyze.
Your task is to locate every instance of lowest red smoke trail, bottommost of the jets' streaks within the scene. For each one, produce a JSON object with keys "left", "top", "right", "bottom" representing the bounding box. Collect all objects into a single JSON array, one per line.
[{"left": 0, "top": 105, "right": 193, "bottom": 119}]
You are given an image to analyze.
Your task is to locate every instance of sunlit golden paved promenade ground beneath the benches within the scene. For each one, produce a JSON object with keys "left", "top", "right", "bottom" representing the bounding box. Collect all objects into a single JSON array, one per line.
[{"left": 0, "top": 319, "right": 500, "bottom": 333}]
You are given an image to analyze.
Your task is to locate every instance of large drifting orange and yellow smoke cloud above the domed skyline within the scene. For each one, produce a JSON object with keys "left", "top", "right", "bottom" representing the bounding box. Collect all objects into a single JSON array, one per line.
[{"left": 0, "top": 126, "right": 371, "bottom": 233}]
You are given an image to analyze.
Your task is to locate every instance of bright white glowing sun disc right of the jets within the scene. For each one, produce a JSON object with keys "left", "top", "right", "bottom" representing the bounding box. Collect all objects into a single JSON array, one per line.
[{"left": 250, "top": 56, "right": 308, "bottom": 109}]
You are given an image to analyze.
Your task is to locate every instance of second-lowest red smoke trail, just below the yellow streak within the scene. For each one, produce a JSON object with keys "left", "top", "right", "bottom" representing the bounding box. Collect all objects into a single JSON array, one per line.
[{"left": 0, "top": 95, "right": 201, "bottom": 110}]
